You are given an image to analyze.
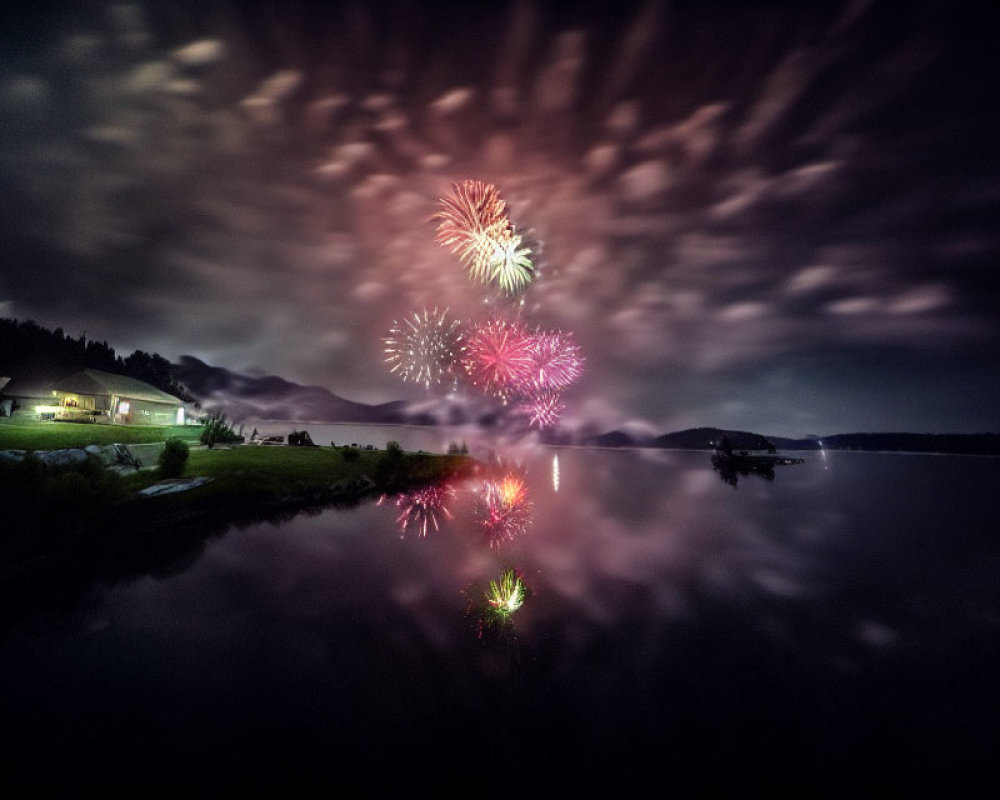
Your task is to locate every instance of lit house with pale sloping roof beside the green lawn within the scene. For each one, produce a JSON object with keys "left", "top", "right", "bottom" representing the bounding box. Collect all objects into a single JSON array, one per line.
[{"left": 49, "top": 369, "right": 184, "bottom": 425}]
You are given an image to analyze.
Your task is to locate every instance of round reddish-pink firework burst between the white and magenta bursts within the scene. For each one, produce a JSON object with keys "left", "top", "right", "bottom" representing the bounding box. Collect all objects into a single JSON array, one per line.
[{"left": 462, "top": 318, "right": 536, "bottom": 401}]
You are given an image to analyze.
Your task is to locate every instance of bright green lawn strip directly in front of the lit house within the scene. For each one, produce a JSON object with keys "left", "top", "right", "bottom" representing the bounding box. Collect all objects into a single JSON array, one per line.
[{"left": 0, "top": 417, "right": 202, "bottom": 450}]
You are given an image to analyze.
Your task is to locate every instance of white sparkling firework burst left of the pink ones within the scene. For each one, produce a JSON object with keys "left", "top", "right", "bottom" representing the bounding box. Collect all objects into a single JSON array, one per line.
[{"left": 383, "top": 308, "right": 465, "bottom": 388}]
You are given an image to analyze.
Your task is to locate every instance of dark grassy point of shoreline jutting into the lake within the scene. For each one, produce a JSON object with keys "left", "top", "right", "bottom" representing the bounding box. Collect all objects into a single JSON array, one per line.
[{"left": 0, "top": 445, "right": 478, "bottom": 564}]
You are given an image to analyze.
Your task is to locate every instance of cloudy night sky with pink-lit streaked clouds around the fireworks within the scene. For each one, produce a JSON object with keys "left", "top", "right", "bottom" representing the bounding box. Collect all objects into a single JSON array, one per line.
[{"left": 0, "top": 0, "right": 1000, "bottom": 437}]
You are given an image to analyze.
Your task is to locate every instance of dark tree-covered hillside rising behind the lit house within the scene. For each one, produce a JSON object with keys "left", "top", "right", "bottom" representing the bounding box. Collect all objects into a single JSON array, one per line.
[{"left": 0, "top": 319, "right": 196, "bottom": 403}]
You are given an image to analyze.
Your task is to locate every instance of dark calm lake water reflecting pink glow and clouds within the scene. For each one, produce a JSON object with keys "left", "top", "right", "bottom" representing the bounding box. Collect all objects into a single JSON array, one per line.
[{"left": 0, "top": 449, "right": 1000, "bottom": 797}]
